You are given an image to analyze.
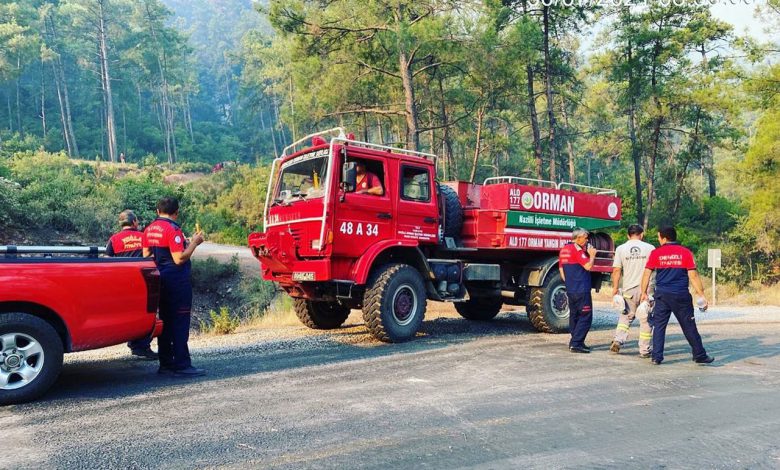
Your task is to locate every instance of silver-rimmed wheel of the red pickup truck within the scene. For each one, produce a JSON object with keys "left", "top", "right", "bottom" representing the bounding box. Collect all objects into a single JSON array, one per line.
[{"left": 0, "top": 313, "right": 63, "bottom": 405}]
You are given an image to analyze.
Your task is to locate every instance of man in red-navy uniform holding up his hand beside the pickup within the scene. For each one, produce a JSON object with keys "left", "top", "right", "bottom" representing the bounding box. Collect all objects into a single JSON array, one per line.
[{"left": 143, "top": 197, "right": 206, "bottom": 377}]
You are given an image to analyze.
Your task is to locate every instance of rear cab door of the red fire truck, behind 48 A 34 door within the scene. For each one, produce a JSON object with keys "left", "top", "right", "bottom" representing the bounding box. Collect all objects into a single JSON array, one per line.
[{"left": 396, "top": 163, "right": 439, "bottom": 243}]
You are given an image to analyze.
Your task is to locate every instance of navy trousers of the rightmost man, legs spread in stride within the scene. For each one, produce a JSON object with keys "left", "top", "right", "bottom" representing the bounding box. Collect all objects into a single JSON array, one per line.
[{"left": 651, "top": 292, "right": 707, "bottom": 362}]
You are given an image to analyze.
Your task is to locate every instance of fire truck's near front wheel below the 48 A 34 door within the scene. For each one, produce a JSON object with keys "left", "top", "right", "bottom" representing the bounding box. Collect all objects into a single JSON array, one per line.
[{"left": 363, "top": 264, "right": 427, "bottom": 343}]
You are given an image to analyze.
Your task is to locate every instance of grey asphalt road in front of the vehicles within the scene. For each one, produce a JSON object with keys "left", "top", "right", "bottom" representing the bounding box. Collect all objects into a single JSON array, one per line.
[{"left": 0, "top": 305, "right": 780, "bottom": 469}]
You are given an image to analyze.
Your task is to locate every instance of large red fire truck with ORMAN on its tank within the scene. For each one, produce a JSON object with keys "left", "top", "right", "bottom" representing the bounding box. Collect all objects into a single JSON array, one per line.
[{"left": 249, "top": 128, "right": 621, "bottom": 342}]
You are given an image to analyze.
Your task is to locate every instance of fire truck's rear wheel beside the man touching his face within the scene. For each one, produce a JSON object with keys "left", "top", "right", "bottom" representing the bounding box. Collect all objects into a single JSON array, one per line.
[{"left": 526, "top": 272, "right": 569, "bottom": 333}]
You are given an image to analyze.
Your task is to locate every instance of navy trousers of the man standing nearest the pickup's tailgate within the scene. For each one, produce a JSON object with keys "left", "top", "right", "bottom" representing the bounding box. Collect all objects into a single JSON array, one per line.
[{"left": 157, "top": 273, "right": 192, "bottom": 370}]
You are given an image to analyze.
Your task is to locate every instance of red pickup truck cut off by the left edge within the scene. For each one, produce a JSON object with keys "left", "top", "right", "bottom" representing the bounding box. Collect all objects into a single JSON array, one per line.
[{"left": 0, "top": 246, "right": 162, "bottom": 405}]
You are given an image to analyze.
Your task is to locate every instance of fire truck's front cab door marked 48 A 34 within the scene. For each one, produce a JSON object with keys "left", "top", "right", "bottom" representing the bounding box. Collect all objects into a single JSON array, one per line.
[{"left": 333, "top": 154, "right": 395, "bottom": 258}]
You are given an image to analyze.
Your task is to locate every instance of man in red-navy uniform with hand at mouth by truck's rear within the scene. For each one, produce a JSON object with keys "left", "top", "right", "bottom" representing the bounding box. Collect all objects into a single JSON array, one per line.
[{"left": 558, "top": 228, "right": 596, "bottom": 353}]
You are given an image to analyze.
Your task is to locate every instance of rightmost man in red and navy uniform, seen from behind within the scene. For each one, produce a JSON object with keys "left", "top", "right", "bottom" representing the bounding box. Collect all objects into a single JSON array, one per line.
[{"left": 640, "top": 227, "right": 715, "bottom": 365}]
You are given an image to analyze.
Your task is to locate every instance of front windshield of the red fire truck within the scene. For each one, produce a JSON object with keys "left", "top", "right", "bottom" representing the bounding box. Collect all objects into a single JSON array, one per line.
[{"left": 274, "top": 149, "right": 329, "bottom": 204}]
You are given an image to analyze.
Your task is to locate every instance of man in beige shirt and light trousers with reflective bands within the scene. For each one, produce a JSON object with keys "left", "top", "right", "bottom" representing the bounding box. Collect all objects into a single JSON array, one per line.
[{"left": 609, "top": 224, "right": 655, "bottom": 358}]
